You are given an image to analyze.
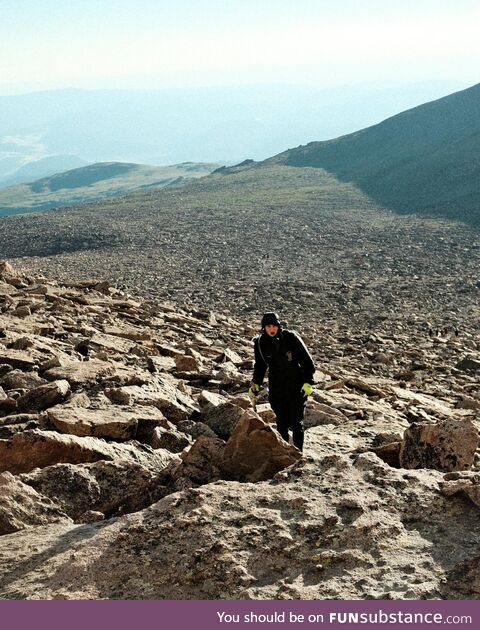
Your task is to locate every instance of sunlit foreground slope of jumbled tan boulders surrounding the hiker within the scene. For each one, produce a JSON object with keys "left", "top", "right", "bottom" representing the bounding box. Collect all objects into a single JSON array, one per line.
[{"left": 0, "top": 263, "right": 480, "bottom": 599}]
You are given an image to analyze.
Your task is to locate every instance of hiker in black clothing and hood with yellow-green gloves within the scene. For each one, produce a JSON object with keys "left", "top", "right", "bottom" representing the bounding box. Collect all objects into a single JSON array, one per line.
[{"left": 248, "top": 313, "right": 315, "bottom": 451}]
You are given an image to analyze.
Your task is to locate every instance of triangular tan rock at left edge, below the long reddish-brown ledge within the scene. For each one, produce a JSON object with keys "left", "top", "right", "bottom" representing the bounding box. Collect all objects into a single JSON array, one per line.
[{"left": 0, "top": 472, "right": 72, "bottom": 536}]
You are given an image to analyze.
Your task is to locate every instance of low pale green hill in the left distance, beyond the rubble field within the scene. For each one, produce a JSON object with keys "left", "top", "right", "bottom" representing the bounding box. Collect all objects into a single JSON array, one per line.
[{"left": 0, "top": 162, "right": 218, "bottom": 216}]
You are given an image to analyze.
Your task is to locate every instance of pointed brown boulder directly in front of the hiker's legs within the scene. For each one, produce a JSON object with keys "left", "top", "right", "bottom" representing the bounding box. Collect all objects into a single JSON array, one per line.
[{"left": 221, "top": 411, "right": 302, "bottom": 481}]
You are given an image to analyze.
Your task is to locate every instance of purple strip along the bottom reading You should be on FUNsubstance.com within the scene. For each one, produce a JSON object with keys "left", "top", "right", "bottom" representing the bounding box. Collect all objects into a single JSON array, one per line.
[{"left": 0, "top": 600, "right": 480, "bottom": 630}]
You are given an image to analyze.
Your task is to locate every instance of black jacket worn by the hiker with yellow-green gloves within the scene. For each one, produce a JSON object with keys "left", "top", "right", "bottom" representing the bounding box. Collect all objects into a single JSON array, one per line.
[{"left": 253, "top": 330, "right": 315, "bottom": 396}]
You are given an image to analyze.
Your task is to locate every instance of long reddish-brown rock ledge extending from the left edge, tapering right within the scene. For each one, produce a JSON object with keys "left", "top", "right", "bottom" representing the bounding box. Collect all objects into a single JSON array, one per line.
[{"left": 0, "top": 429, "right": 176, "bottom": 474}]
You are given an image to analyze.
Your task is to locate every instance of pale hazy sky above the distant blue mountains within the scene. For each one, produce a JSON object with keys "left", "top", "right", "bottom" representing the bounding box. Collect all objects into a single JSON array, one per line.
[{"left": 0, "top": 0, "right": 480, "bottom": 94}]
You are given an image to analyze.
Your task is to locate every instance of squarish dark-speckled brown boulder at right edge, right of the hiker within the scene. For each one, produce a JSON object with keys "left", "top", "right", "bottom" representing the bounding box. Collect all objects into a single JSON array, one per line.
[{"left": 400, "top": 419, "right": 479, "bottom": 472}]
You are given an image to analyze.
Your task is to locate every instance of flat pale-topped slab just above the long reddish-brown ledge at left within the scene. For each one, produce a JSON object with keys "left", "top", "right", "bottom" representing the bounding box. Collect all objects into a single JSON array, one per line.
[{"left": 48, "top": 405, "right": 164, "bottom": 440}]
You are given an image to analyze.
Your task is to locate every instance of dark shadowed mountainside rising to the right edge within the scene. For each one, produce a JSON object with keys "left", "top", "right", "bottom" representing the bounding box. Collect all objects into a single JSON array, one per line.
[{"left": 268, "top": 84, "right": 480, "bottom": 224}]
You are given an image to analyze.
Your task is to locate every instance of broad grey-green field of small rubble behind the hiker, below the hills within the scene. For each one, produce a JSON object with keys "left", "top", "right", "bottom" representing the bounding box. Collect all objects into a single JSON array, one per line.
[{"left": 0, "top": 164, "right": 480, "bottom": 346}]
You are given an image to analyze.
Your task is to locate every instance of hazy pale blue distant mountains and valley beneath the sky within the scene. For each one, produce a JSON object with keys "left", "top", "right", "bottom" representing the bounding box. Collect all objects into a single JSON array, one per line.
[{"left": 0, "top": 81, "right": 466, "bottom": 178}]
